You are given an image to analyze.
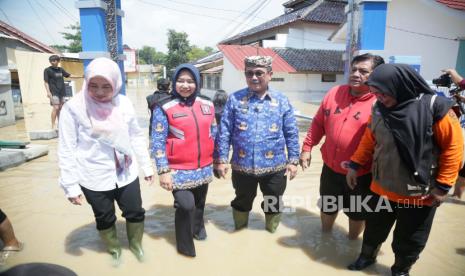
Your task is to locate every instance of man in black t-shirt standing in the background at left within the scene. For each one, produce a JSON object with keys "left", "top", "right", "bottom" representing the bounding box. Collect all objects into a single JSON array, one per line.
[{"left": 44, "top": 55, "right": 71, "bottom": 129}]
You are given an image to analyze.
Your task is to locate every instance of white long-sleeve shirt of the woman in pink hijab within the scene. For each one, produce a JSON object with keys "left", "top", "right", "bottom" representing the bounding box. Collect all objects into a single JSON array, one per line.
[{"left": 58, "top": 95, "right": 154, "bottom": 197}]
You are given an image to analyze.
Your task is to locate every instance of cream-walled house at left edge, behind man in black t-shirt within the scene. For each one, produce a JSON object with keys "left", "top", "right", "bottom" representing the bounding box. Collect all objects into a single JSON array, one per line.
[{"left": 0, "top": 21, "right": 84, "bottom": 134}]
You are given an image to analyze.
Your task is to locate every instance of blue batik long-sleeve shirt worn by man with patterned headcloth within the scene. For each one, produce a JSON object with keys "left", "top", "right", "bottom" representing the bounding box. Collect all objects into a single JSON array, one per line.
[{"left": 214, "top": 88, "right": 299, "bottom": 175}]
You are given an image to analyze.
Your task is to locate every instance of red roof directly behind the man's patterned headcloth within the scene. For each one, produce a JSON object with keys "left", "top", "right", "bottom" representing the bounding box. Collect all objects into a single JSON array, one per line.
[{"left": 218, "top": 44, "right": 296, "bottom": 73}]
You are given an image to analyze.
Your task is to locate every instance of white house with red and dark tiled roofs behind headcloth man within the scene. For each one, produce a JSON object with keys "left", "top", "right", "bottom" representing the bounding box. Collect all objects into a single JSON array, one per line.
[{"left": 195, "top": 0, "right": 347, "bottom": 102}]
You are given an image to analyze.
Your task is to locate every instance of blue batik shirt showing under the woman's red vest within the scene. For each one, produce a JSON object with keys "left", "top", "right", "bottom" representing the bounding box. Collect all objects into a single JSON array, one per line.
[{"left": 151, "top": 106, "right": 217, "bottom": 190}]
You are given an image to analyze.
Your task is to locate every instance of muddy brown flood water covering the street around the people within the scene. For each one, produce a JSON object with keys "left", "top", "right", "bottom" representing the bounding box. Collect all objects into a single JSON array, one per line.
[{"left": 0, "top": 87, "right": 465, "bottom": 276}]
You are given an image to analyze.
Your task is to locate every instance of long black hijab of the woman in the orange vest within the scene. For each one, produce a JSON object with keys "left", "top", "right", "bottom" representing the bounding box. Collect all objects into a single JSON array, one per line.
[{"left": 366, "top": 64, "right": 453, "bottom": 185}]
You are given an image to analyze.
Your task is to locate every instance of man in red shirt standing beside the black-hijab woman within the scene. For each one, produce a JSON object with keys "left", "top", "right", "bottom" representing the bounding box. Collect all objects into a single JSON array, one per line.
[{"left": 299, "top": 53, "right": 384, "bottom": 240}]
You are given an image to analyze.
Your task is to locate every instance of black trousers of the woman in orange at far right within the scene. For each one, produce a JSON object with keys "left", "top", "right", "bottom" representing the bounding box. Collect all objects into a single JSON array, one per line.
[{"left": 363, "top": 195, "right": 436, "bottom": 265}]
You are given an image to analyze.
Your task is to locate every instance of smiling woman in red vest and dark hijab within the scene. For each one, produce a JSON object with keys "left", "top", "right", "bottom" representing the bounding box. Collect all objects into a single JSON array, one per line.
[{"left": 151, "top": 64, "right": 216, "bottom": 257}]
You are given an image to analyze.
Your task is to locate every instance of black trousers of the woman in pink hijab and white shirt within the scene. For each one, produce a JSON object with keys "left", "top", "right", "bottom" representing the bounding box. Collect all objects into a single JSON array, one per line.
[{"left": 81, "top": 178, "right": 145, "bottom": 231}]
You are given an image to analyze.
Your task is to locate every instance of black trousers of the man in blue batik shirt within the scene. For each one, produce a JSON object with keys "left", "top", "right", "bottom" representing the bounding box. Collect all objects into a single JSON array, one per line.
[{"left": 231, "top": 170, "right": 287, "bottom": 214}]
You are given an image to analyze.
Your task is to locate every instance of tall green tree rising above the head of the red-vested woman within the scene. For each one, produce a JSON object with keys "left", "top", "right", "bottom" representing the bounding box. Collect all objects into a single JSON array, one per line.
[{"left": 166, "top": 29, "right": 191, "bottom": 70}]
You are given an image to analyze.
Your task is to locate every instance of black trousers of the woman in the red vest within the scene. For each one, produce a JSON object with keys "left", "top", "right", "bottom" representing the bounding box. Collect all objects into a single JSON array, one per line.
[{"left": 173, "top": 184, "right": 208, "bottom": 256}]
